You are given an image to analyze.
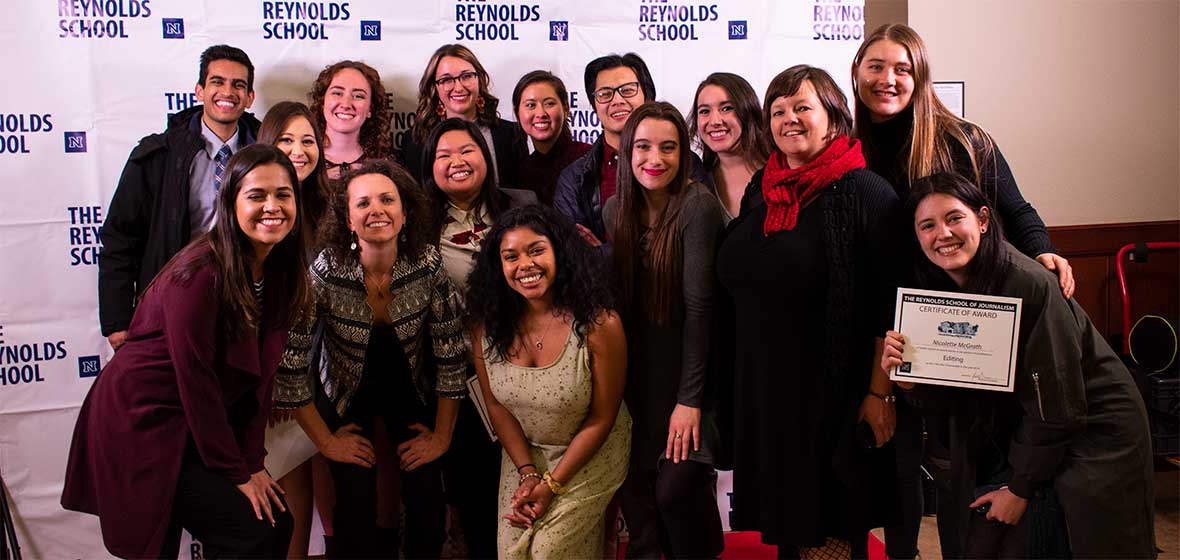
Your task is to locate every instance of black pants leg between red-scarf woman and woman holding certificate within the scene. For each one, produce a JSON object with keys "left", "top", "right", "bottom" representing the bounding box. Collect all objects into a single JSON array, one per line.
[{"left": 885, "top": 398, "right": 924, "bottom": 559}]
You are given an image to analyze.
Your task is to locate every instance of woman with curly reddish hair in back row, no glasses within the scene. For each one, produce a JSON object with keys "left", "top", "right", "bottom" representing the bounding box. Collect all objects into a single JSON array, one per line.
[{"left": 309, "top": 60, "right": 393, "bottom": 180}]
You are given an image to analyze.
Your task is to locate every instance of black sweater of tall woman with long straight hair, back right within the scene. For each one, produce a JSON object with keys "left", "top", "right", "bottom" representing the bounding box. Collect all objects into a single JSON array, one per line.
[{"left": 863, "top": 108, "right": 1057, "bottom": 257}]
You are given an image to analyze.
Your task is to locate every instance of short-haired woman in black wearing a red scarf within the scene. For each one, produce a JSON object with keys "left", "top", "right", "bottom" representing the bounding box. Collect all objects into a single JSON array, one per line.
[{"left": 717, "top": 65, "right": 899, "bottom": 558}]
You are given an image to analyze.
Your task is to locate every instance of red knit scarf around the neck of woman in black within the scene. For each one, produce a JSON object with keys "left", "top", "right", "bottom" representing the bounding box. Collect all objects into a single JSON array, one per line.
[{"left": 762, "top": 136, "right": 865, "bottom": 236}]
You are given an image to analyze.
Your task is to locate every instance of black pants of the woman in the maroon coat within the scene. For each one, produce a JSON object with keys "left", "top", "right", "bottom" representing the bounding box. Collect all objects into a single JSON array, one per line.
[{"left": 159, "top": 446, "right": 295, "bottom": 560}]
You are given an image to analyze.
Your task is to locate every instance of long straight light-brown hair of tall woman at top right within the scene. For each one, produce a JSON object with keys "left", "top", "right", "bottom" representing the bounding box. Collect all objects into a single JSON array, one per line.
[{"left": 852, "top": 24, "right": 995, "bottom": 188}]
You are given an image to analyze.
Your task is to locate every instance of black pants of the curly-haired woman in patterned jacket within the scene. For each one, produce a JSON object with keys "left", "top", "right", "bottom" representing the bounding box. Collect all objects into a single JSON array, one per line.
[{"left": 316, "top": 380, "right": 446, "bottom": 559}]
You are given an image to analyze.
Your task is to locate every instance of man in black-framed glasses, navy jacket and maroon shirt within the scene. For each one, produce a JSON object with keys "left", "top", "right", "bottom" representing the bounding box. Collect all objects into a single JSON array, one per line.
[{"left": 553, "top": 53, "right": 713, "bottom": 246}]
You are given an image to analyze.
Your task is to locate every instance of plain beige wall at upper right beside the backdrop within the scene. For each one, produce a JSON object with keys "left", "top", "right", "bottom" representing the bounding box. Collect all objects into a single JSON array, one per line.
[{"left": 901, "top": 0, "right": 1180, "bottom": 225}]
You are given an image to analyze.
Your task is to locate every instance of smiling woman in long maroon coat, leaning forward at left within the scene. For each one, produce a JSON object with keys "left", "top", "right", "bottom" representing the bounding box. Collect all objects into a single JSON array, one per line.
[{"left": 61, "top": 145, "right": 308, "bottom": 558}]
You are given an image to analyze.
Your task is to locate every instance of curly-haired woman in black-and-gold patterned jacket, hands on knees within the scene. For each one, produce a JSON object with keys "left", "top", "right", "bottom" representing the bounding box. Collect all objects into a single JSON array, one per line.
[{"left": 276, "top": 159, "right": 466, "bottom": 558}]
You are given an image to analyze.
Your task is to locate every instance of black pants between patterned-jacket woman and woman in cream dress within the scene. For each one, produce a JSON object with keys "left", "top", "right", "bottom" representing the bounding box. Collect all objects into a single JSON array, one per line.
[{"left": 443, "top": 398, "right": 503, "bottom": 559}]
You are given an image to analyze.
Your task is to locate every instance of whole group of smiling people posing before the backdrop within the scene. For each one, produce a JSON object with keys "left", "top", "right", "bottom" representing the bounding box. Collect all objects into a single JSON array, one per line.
[{"left": 63, "top": 25, "right": 1155, "bottom": 558}]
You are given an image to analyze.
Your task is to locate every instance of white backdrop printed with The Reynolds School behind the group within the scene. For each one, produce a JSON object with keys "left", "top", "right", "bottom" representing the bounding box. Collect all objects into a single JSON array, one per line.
[{"left": 0, "top": 0, "right": 865, "bottom": 558}]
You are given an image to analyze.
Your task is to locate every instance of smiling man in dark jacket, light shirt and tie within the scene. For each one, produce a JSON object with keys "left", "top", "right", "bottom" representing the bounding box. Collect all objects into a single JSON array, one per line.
[{"left": 98, "top": 45, "right": 258, "bottom": 349}]
